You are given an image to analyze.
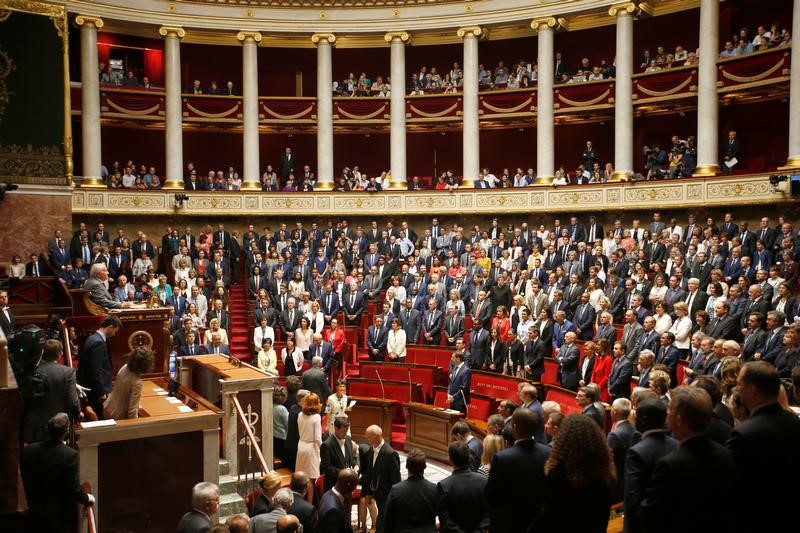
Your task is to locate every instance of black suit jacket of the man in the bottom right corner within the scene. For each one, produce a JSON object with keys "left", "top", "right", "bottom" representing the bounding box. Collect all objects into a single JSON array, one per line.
[{"left": 727, "top": 403, "right": 800, "bottom": 531}]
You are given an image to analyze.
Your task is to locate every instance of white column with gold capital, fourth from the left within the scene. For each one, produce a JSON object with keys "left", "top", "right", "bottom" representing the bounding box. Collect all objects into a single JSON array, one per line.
[{"left": 311, "top": 33, "right": 336, "bottom": 191}]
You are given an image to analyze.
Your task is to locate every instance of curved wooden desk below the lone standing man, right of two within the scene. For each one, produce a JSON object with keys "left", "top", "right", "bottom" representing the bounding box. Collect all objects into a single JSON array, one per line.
[{"left": 404, "top": 402, "right": 464, "bottom": 463}]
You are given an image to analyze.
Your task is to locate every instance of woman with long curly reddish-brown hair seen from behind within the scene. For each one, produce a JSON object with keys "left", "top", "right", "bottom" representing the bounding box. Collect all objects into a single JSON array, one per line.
[{"left": 535, "top": 414, "right": 615, "bottom": 533}]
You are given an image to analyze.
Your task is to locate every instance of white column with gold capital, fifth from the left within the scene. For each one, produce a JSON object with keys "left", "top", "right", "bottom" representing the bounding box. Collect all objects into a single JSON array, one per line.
[{"left": 384, "top": 31, "right": 411, "bottom": 190}]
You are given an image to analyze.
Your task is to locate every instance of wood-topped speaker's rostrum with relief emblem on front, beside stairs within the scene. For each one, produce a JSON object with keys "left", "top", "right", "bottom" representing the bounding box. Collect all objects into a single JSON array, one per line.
[{"left": 180, "top": 355, "right": 276, "bottom": 475}]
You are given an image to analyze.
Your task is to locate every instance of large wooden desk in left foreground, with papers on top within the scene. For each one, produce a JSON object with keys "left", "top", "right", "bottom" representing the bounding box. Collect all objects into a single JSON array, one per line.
[{"left": 76, "top": 379, "right": 221, "bottom": 533}]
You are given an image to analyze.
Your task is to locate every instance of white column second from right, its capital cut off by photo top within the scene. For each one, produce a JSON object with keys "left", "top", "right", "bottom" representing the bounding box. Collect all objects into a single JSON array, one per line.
[{"left": 694, "top": 0, "right": 719, "bottom": 176}]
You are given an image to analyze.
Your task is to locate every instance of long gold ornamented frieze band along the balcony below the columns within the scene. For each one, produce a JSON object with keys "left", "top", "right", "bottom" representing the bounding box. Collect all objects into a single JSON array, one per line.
[{"left": 72, "top": 174, "right": 792, "bottom": 217}]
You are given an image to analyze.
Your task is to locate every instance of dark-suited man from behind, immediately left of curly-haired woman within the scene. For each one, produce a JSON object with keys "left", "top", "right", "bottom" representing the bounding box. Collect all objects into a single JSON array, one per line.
[{"left": 484, "top": 409, "right": 550, "bottom": 532}]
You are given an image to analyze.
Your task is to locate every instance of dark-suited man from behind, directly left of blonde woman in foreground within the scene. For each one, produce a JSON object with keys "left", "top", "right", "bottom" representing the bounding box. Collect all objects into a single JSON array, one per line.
[{"left": 436, "top": 441, "right": 488, "bottom": 531}]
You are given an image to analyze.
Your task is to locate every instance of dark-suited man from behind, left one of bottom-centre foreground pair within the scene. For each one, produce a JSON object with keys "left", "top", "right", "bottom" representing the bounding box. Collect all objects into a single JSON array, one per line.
[{"left": 385, "top": 448, "right": 437, "bottom": 533}]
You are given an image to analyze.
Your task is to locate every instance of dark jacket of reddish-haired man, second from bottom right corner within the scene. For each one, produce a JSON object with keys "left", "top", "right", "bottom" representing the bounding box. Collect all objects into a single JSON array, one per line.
[{"left": 642, "top": 435, "right": 735, "bottom": 533}]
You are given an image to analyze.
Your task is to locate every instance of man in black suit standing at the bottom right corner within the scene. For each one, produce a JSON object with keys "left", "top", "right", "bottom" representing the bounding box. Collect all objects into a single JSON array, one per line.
[{"left": 727, "top": 361, "right": 800, "bottom": 531}]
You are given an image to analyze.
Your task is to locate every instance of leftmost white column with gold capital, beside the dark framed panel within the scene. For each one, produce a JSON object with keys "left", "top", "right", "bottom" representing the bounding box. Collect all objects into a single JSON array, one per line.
[{"left": 75, "top": 15, "right": 105, "bottom": 187}]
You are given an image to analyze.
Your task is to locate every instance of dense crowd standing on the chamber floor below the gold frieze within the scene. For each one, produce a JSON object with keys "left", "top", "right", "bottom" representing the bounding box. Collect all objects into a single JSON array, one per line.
[{"left": 10, "top": 207, "right": 800, "bottom": 531}]
